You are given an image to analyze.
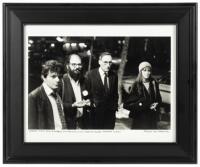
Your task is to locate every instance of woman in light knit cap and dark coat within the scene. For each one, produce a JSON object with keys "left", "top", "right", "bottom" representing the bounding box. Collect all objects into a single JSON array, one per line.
[{"left": 123, "top": 62, "right": 162, "bottom": 129}]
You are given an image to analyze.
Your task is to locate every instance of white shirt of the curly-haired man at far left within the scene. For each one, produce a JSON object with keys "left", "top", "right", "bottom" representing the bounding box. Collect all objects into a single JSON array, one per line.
[{"left": 42, "top": 82, "right": 63, "bottom": 130}]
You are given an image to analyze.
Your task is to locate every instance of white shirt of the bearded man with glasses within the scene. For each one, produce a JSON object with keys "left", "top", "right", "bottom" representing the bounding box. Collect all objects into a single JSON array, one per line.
[{"left": 68, "top": 75, "right": 83, "bottom": 118}]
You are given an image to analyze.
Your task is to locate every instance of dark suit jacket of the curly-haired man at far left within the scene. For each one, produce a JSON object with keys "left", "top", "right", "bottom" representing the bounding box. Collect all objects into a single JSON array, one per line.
[{"left": 28, "top": 86, "right": 55, "bottom": 129}]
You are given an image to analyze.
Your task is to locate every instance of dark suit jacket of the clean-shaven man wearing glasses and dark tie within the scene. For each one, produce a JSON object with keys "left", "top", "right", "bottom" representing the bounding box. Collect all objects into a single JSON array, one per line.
[{"left": 86, "top": 68, "right": 118, "bottom": 113}]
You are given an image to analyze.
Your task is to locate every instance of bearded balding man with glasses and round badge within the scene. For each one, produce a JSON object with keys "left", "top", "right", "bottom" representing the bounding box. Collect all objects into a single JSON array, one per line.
[{"left": 62, "top": 54, "right": 90, "bottom": 129}]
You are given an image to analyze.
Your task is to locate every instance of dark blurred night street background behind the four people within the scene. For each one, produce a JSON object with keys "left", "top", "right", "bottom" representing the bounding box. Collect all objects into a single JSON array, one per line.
[{"left": 28, "top": 36, "right": 171, "bottom": 129}]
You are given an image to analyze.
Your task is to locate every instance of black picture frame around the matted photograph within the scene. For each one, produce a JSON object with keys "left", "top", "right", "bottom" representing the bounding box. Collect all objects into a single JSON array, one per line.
[{"left": 3, "top": 3, "right": 197, "bottom": 163}]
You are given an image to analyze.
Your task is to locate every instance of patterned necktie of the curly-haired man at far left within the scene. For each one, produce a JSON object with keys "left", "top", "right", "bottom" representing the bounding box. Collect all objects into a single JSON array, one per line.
[{"left": 52, "top": 93, "right": 67, "bottom": 129}]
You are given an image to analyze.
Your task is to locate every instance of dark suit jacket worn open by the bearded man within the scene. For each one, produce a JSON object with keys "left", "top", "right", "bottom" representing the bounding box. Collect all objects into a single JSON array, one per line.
[{"left": 62, "top": 74, "right": 87, "bottom": 124}]
